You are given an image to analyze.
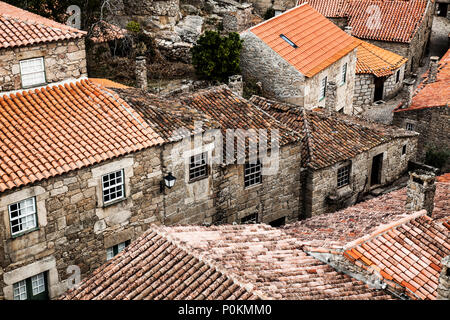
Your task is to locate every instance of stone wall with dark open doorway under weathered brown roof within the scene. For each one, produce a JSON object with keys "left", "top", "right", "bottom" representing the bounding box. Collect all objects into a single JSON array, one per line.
[{"left": 303, "top": 137, "right": 417, "bottom": 217}]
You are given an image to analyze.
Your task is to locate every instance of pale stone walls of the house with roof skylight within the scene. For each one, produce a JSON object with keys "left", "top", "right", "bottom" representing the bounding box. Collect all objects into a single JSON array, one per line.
[{"left": 241, "top": 31, "right": 356, "bottom": 114}]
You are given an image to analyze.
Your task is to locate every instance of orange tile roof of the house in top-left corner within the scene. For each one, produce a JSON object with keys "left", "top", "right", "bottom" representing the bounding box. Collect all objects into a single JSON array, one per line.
[{"left": 0, "top": 1, "right": 86, "bottom": 49}]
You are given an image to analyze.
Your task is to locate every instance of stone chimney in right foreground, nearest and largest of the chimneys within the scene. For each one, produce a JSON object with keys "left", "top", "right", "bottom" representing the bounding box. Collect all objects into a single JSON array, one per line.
[{"left": 406, "top": 170, "right": 436, "bottom": 217}]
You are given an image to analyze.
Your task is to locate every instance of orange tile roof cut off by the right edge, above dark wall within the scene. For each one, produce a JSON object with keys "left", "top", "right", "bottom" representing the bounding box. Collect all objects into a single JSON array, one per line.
[{"left": 394, "top": 50, "right": 450, "bottom": 112}]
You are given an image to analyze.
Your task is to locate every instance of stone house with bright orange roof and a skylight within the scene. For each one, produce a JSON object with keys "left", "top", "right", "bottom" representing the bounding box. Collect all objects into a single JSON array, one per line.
[{"left": 241, "top": 4, "right": 357, "bottom": 114}]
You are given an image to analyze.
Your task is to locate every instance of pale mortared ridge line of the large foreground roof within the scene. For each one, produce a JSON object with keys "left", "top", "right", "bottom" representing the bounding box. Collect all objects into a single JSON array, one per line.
[{"left": 150, "top": 225, "right": 273, "bottom": 300}]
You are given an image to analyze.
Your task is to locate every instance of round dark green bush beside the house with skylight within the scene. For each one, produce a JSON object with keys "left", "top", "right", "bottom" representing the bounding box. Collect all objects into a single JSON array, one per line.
[{"left": 191, "top": 31, "right": 242, "bottom": 82}]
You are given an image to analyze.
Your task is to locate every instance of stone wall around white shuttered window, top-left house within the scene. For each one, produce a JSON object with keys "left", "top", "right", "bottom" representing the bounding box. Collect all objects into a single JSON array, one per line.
[{"left": 0, "top": 38, "right": 87, "bottom": 91}]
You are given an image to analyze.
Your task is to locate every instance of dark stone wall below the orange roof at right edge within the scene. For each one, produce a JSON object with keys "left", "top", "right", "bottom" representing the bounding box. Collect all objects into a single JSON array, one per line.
[{"left": 393, "top": 106, "right": 450, "bottom": 161}]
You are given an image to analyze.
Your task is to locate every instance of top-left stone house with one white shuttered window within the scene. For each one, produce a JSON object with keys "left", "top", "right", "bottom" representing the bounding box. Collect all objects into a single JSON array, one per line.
[{"left": 0, "top": 1, "right": 87, "bottom": 91}]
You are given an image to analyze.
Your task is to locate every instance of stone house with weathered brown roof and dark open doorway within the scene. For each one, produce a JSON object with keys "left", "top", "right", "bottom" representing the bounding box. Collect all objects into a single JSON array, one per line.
[{"left": 250, "top": 96, "right": 418, "bottom": 217}]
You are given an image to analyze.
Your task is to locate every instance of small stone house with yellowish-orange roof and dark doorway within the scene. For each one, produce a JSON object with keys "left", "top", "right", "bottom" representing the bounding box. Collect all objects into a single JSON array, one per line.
[{"left": 353, "top": 41, "right": 407, "bottom": 109}]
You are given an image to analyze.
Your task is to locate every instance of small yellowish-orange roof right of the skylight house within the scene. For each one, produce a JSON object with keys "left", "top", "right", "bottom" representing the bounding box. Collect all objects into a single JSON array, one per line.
[{"left": 356, "top": 40, "right": 408, "bottom": 77}]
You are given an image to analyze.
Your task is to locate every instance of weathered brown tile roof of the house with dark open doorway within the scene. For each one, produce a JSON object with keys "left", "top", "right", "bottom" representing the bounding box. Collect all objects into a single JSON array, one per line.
[{"left": 250, "top": 96, "right": 417, "bottom": 169}]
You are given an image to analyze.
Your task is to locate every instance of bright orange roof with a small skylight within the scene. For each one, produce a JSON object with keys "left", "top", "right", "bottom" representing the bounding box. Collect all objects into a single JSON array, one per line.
[{"left": 250, "top": 4, "right": 357, "bottom": 77}]
